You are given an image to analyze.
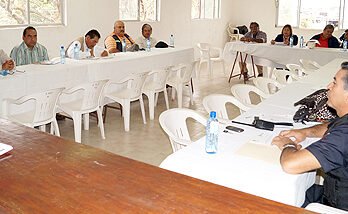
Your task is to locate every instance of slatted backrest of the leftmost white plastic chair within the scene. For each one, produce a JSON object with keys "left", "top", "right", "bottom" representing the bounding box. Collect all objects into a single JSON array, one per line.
[{"left": 32, "top": 88, "right": 64, "bottom": 123}]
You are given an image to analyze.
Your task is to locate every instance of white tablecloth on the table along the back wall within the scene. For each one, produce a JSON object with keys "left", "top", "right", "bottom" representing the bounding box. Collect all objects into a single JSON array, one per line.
[{"left": 223, "top": 42, "right": 348, "bottom": 67}]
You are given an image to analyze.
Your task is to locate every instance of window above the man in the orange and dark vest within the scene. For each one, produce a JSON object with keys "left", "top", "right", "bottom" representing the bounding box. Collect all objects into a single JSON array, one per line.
[{"left": 119, "top": 0, "right": 159, "bottom": 21}]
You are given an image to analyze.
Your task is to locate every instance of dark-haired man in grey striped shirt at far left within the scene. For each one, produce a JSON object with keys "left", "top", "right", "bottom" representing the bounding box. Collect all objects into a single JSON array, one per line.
[{"left": 10, "top": 26, "right": 49, "bottom": 65}]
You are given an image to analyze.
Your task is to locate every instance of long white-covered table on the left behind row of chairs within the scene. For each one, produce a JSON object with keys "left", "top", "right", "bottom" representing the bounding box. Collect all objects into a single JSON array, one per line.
[{"left": 0, "top": 47, "right": 194, "bottom": 113}]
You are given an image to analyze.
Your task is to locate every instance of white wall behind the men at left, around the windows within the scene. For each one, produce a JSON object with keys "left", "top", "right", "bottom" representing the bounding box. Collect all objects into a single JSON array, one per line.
[{"left": 0, "top": 0, "right": 233, "bottom": 57}]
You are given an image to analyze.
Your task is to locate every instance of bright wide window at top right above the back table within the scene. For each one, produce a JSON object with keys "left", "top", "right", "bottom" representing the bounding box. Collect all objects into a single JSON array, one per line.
[{"left": 276, "top": 0, "right": 348, "bottom": 29}]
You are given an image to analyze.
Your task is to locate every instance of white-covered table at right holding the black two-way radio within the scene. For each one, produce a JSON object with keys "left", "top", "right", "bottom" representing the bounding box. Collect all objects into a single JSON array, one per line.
[{"left": 160, "top": 59, "right": 345, "bottom": 206}]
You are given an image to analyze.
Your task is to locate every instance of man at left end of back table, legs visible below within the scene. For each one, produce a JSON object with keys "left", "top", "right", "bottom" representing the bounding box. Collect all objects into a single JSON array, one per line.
[{"left": 239, "top": 22, "right": 267, "bottom": 79}]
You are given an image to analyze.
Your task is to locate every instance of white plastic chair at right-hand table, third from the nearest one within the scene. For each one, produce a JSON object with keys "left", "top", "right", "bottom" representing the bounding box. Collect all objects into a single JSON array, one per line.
[{"left": 231, "top": 84, "right": 269, "bottom": 107}]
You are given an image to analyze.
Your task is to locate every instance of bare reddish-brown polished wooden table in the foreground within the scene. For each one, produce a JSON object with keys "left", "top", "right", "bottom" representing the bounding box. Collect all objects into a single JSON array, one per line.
[{"left": 0, "top": 119, "right": 312, "bottom": 213}]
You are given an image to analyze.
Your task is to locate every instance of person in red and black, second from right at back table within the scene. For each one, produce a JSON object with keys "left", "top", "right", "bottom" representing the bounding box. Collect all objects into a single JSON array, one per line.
[{"left": 311, "top": 24, "right": 340, "bottom": 48}]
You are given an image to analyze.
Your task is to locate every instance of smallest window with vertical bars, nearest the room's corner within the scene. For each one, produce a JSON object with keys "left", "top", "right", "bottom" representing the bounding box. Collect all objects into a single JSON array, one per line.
[{"left": 191, "top": 0, "right": 221, "bottom": 19}]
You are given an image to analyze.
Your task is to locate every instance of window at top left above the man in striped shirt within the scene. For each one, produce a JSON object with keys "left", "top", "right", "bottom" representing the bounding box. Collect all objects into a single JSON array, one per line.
[{"left": 0, "top": 0, "right": 64, "bottom": 26}]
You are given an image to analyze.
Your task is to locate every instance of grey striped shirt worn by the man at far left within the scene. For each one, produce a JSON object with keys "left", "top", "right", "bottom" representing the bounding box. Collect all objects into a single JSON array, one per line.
[{"left": 10, "top": 42, "right": 49, "bottom": 66}]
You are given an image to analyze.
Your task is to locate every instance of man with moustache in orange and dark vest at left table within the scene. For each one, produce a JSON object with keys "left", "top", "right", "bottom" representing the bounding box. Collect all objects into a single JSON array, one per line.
[{"left": 104, "top": 21, "right": 135, "bottom": 53}]
